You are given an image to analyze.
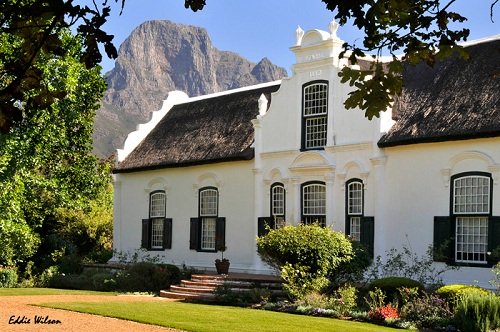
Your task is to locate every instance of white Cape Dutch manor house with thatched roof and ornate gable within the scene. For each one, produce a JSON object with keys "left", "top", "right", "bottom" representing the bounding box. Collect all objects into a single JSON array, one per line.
[{"left": 113, "top": 21, "right": 500, "bottom": 286}]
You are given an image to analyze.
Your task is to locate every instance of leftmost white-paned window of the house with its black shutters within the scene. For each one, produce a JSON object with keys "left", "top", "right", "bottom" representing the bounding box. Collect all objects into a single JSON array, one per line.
[{"left": 141, "top": 191, "right": 172, "bottom": 250}]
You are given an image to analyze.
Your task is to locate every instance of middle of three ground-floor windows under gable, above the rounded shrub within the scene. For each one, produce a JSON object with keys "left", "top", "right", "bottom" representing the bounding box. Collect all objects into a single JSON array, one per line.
[{"left": 302, "top": 182, "right": 326, "bottom": 227}]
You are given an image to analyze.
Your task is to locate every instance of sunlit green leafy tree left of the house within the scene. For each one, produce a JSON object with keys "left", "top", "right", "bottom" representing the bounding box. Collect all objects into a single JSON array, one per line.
[{"left": 0, "top": 30, "right": 110, "bottom": 265}]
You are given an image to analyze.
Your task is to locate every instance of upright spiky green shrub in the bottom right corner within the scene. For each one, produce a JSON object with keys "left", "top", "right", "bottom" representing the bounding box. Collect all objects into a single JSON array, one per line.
[{"left": 454, "top": 293, "right": 500, "bottom": 332}]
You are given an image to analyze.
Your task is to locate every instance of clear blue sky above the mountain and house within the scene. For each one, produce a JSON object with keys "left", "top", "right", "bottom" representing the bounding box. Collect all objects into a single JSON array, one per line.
[{"left": 101, "top": 0, "right": 500, "bottom": 73}]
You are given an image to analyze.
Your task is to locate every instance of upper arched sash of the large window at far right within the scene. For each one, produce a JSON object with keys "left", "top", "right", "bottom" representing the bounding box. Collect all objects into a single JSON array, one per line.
[{"left": 453, "top": 176, "right": 490, "bottom": 214}]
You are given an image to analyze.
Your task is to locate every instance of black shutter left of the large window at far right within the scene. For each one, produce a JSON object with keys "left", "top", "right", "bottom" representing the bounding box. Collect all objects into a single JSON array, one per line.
[{"left": 433, "top": 216, "right": 455, "bottom": 264}]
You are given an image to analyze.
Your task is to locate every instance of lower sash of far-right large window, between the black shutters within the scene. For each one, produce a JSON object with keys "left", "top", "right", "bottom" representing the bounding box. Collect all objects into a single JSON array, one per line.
[{"left": 455, "top": 217, "right": 488, "bottom": 263}]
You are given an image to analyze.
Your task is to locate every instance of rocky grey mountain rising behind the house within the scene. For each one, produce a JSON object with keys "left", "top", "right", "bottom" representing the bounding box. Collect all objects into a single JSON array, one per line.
[{"left": 94, "top": 20, "right": 287, "bottom": 156}]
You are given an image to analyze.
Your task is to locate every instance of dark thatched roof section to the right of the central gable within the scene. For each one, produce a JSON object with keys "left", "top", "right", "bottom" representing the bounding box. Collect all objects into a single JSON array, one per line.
[{"left": 378, "top": 38, "right": 500, "bottom": 147}]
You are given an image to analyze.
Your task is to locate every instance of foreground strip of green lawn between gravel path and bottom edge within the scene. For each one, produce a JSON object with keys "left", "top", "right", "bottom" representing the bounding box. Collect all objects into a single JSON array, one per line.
[{"left": 43, "top": 299, "right": 396, "bottom": 332}]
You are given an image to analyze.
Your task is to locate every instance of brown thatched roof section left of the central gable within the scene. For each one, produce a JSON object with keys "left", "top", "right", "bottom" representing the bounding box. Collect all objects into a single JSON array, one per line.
[{"left": 114, "top": 83, "right": 280, "bottom": 173}]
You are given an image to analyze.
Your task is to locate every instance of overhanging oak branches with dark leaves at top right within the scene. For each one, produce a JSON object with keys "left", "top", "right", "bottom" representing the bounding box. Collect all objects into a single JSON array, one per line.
[{"left": 185, "top": 0, "right": 498, "bottom": 119}]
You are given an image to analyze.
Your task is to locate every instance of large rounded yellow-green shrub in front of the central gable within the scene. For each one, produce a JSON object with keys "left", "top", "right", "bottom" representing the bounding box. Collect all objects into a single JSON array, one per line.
[{"left": 257, "top": 224, "right": 353, "bottom": 298}]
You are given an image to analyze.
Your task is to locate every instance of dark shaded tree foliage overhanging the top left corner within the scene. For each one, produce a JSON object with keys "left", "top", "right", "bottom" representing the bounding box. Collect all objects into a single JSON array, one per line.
[{"left": 0, "top": 0, "right": 125, "bottom": 133}]
